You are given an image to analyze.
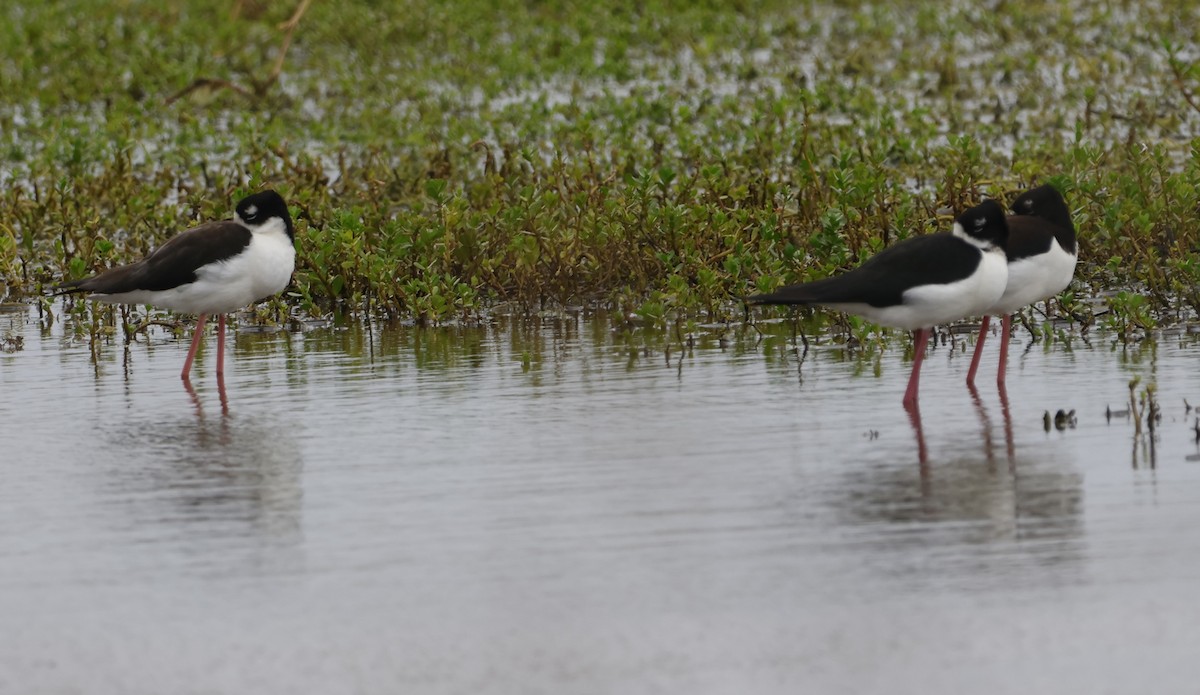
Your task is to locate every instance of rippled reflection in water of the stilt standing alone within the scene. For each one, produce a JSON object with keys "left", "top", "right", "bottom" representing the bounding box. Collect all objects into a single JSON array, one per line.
[{"left": 102, "top": 388, "right": 304, "bottom": 573}]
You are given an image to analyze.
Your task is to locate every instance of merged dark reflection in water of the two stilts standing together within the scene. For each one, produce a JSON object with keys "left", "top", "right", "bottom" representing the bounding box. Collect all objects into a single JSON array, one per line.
[{"left": 832, "top": 389, "right": 1084, "bottom": 586}]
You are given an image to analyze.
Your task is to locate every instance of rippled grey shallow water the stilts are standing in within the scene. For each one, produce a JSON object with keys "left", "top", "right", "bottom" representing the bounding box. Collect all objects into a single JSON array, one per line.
[{"left": 0, "top": 311, "right": 1200, "bottom": 694}]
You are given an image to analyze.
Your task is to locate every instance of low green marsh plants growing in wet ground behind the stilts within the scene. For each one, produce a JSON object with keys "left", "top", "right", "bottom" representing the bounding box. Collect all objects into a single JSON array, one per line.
[{"left": 0, "top": 0, "right": 1200, "bottom": 336}]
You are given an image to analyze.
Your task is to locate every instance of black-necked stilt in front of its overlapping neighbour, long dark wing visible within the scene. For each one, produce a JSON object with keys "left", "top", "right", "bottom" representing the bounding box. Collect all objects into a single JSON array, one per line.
[{"left": 746, "top": 200, "right": 1008, "bottom": 406}]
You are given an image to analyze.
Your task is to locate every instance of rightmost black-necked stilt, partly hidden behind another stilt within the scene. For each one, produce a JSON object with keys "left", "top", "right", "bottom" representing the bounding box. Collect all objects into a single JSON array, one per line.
[{"left": 967, "top": 185, "right": 1079, "bottom": 384}]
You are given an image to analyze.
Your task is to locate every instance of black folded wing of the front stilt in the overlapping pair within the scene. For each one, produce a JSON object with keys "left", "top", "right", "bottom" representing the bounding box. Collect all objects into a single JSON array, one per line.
[{"left": 746, "top": 232, "right": 983, "bottom": 306}]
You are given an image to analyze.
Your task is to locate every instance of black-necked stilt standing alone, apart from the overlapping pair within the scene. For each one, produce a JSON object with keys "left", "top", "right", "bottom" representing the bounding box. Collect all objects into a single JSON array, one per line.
[{"left": 58, "top": 191, "right": 296, "bottom": 382}]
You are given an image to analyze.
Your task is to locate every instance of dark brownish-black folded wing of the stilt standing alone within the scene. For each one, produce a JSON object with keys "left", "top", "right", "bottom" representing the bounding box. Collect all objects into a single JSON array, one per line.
[{"left": 59, "top": 220, "right": 252, "bottom": 294}]
